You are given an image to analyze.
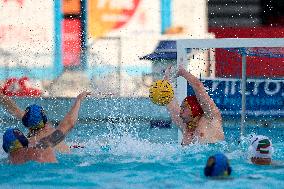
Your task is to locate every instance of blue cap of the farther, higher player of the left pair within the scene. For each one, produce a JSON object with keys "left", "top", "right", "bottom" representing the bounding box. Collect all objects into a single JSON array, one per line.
[{"left": 22, "top": 104, "right": 47, "bottom": 129}]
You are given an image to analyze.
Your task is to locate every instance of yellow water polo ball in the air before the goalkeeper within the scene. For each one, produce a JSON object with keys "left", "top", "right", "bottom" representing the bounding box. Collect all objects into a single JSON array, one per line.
[{"left": 149, "top": 80, "right": 174, "bottom": 106}]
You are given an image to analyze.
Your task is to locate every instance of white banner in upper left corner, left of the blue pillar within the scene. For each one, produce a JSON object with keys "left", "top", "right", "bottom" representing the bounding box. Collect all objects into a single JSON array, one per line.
[{"left": 0, "top": 0, "right": 54, "bottom": 68}]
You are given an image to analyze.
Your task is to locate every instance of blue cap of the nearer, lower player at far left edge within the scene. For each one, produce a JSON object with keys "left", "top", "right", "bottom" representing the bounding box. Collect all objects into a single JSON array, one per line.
[{"left": 2, "top": 128, "right": 29, "bottom": 153}]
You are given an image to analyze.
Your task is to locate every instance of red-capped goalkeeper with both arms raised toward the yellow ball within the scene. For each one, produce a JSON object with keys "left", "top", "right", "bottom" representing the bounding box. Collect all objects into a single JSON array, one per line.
[{"left": 164, "top": 66, "right": 224, "bottom": 145}]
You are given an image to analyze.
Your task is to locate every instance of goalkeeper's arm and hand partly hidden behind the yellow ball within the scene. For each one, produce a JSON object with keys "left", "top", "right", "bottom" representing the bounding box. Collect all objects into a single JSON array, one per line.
[{"left": 164, "top": 66, "right": 186, "bottom": 131}]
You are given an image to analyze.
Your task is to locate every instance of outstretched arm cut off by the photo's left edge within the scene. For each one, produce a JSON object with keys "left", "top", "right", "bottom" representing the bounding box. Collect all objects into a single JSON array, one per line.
[{"left": 0, "top": 93, "right": 25, "bottom": 119}]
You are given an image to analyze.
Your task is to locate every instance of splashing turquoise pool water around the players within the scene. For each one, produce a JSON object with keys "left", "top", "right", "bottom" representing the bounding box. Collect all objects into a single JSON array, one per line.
[{"left": 0, "top": 121, "right": 284, "bottom": 189}]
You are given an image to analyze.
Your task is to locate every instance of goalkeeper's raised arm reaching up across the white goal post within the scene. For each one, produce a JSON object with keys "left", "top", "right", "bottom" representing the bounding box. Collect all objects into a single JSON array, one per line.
[{"left": 177, "top": 65, "right": 222, "bottom": 121}]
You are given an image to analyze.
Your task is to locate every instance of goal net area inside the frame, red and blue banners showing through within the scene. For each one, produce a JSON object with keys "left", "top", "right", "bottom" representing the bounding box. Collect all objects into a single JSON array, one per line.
[{"left": 184, "top": 44, "right": 284, "bottom": 126}]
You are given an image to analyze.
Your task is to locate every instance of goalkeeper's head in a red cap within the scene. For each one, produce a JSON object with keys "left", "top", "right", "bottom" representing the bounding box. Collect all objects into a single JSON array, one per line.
[{"left": 180, "top": 96, "right": 204, "bottom": 123}]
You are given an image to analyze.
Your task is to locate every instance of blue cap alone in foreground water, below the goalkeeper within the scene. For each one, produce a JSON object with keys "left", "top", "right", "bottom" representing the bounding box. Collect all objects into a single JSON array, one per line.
[{"left": 204, "top": 153, "right": 232, "bottom": 177}]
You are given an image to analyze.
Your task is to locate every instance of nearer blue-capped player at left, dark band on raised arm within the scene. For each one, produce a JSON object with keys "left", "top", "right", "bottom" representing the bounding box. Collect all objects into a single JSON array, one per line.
[{"left": 3, "top": 92, "right": 90, "bottom": 164}]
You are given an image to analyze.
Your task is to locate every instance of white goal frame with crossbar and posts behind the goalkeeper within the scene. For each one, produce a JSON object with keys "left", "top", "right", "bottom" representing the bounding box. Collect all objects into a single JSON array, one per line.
[{"left": 176, "top": 38, "right": 284, "bottom": 139}]
